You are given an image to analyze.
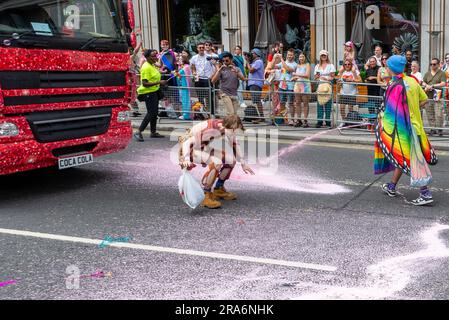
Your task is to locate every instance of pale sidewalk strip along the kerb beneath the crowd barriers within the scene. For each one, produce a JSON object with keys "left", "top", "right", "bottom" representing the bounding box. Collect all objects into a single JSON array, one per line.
[{"left": 132, "top": 117, "right": 449, "bottom": 151}]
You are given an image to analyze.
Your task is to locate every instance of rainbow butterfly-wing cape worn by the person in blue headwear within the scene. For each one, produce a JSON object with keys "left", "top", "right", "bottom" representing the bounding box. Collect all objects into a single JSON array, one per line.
[{"left": 374, "top": 77, "right": 438, "bottom": 187}]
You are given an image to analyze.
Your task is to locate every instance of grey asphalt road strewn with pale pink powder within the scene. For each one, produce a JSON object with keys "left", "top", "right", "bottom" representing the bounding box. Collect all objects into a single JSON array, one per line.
[{"left": 0, "top": 139, "right": 449, "bottom": 300}]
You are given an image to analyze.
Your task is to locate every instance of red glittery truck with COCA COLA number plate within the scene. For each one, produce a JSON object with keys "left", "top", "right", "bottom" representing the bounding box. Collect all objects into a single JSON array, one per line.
[{"left": 0, "top": 0, "right": 135, "bottom": 175}]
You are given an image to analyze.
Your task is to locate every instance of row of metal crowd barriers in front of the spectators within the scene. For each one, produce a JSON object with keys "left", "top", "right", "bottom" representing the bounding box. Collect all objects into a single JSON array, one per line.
[{"left": 131, "top": 74, "right": 449, "bottom": 135}]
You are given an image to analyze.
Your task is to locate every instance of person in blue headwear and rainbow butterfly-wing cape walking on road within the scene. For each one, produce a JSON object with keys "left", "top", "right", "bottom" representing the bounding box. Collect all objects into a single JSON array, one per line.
[{"left": 374, "top": 55, "right": 438, "bottom": 206}]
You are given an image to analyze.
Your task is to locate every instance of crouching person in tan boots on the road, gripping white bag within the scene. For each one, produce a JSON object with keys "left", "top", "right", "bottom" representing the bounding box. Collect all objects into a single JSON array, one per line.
[{"left": 179, "top": 115, "right": 255, "bottom": 209}]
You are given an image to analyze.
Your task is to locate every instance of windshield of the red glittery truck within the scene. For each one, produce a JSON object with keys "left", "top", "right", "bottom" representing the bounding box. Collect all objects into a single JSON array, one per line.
[{"left": 0, "top": 0, "right": 128, "bottom": 52}]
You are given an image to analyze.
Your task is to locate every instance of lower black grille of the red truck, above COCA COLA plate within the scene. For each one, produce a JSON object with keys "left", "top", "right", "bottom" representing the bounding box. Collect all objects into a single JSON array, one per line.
[{"left": 26, "top": 107, "right": 112, "bottom": 142}]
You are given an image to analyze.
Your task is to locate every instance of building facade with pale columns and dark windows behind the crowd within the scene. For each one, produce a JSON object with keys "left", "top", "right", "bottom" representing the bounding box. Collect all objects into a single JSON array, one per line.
[{"left": 133, "top": 0, "right": 449, "bottom": 71}]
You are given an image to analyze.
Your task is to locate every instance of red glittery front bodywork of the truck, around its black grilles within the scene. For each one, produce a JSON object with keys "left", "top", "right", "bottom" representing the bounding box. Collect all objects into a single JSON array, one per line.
[{"left": 0, "top": 48, "right": 132, "bottom": 174}]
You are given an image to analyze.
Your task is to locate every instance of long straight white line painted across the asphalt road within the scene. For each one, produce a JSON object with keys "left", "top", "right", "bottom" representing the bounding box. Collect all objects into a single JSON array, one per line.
[{"left": 0, "top": 228, "right": 337, "bottom": 272}]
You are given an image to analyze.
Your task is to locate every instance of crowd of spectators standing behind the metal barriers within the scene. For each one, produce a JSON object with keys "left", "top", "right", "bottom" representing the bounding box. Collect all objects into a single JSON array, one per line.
[{"left": 132, "top": 40, "right": 449, "bottom": 135}]
